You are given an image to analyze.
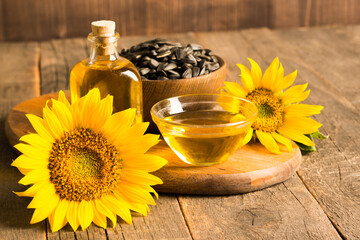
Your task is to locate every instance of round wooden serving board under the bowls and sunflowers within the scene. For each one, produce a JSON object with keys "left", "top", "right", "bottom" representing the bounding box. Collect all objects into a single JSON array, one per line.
[{"left": 5, "top": 93, "right": 302, "bottom": 195}]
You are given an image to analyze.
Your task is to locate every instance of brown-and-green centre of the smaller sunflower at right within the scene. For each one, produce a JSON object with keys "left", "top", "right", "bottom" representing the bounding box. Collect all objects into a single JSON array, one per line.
[{"left": 246, "top": 88, "right": 284, "bottom": 132}]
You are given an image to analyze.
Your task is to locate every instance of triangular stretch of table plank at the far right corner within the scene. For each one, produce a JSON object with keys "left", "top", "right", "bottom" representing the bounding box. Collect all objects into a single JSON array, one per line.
[{"left": 275, "top": 26, "right": 360, "bottom": 110}]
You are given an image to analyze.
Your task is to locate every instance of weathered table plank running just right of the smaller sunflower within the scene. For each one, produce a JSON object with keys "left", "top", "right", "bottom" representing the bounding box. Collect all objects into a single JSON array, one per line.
[{"left": 241, "top": 29, "right": 360, "bottom": 239}]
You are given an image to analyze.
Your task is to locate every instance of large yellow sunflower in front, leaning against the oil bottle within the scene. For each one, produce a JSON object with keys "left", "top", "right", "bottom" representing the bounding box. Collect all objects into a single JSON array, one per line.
[{"left": 12, "top": 89, "right": 167, "bottom": 231}]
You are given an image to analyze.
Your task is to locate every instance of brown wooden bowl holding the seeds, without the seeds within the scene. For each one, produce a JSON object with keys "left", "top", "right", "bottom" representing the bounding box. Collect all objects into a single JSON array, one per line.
[{"left": 142, "top": 56, "right": 226, "bottom": 133}]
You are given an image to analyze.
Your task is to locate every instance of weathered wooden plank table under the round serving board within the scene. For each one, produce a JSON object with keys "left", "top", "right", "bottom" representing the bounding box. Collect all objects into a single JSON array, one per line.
[{"left": 0, "top": 26, "right": 360, "bottom": 240}]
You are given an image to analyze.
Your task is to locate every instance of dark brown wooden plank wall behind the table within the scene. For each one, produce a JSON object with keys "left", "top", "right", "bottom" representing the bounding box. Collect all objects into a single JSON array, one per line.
[{"left": 0, "top": 0, "right": 360, "bottom": 41}]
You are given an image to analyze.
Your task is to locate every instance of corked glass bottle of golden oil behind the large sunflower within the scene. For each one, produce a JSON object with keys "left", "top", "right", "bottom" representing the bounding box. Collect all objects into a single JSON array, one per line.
[{"left": 70, "top": 21, "right": 142, "bottom": 123}]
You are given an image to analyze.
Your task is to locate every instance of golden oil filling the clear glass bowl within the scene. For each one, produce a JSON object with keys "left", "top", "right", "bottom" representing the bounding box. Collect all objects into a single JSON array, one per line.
[{"left": 159, "top": 110, "right": 251, "bottom": 166}]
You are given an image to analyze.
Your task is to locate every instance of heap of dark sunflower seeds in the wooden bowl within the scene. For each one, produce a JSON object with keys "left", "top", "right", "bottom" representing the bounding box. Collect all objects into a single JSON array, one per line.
[{"left": 120, "top": 39, "right": 220, "bottom": 80}]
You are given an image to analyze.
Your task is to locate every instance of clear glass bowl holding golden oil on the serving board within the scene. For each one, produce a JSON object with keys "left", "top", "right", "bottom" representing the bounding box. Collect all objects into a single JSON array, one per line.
[{"left": 150, "top": 94, "right": 257, "bottom": 166}]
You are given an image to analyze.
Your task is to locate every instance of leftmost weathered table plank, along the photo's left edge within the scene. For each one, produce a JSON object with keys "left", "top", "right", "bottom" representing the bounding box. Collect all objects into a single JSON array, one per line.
[{"left": 0, "top": 42, "right": 46, "bottom": 239}]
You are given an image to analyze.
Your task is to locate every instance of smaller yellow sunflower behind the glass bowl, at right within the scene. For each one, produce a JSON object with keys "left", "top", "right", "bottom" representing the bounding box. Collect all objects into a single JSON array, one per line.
[{"left": 222, "top": 58, "right": 323, "bottom": 154}]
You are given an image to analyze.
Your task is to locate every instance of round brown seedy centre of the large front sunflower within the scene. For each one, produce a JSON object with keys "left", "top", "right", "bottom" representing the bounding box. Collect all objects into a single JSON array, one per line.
[{"left": 48, "top": 128, "right": 122, "bottom": 201}]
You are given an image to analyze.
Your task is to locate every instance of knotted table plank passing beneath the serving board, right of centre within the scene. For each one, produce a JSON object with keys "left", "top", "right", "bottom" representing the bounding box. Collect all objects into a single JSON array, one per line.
[{"left": 179, "top": 32, "right": 340, "bottom": 239}]
